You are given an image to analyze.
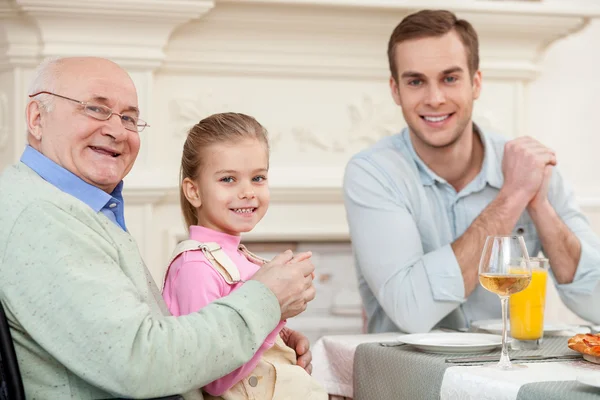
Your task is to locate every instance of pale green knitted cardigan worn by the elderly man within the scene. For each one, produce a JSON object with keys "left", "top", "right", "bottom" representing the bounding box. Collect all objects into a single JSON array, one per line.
[{"left": 0, "top": 163, "right": 280, "bottom": 400}]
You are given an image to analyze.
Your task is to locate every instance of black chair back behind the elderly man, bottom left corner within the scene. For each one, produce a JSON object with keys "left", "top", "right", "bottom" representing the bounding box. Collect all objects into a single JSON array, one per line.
[{"left": 0, "top": 302, "right": 25, "bottom": 400}]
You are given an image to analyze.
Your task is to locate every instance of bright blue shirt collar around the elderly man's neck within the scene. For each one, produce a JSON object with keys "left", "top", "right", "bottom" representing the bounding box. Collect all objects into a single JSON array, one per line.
[{"left": 21, "top": 146, "right": 127, "bottom": 231}]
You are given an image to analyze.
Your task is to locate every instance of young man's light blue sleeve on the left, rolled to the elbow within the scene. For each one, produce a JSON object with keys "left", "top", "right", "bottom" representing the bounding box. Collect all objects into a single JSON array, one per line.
[{"left": 344, "top": 158, "right": 465, "bottom": 333}]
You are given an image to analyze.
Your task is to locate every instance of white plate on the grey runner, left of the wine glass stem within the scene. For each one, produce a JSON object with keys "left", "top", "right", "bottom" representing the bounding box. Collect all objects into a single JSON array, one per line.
[{"left": 398, "top": 332, "right": 502, "bottom": 353}]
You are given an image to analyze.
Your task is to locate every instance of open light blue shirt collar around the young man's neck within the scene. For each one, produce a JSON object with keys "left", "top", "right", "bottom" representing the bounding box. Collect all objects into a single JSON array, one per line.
[{"left": 401, "top": 123, "right": 504, "bottom": 189}]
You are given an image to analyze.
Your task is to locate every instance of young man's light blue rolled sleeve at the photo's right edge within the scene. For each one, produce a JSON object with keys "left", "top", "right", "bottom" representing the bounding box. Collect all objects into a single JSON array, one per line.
[{"left": 542, "top": 169, "right": 600, "bottom": 324}]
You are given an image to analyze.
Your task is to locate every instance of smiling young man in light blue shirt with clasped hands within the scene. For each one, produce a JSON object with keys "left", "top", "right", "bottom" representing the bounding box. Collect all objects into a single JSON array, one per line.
[{"left": 344, "top": 10, "right": 600, "bottom": 332}]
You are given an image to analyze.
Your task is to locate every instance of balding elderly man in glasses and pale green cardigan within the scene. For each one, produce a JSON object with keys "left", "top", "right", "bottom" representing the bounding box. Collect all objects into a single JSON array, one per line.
[{"left": 0, "top": 58, "right": 315, "bottom": 399}]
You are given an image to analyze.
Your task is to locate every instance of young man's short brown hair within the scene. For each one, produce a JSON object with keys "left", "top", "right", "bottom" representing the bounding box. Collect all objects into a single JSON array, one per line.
[{"left": 388, "top": 10, "right": 479, "bottom": 82}]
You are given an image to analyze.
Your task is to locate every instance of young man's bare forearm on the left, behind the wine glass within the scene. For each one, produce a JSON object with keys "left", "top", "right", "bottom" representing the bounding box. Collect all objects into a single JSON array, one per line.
[{"left": 452, "top": 192, "right": 527, "bottom": 297}]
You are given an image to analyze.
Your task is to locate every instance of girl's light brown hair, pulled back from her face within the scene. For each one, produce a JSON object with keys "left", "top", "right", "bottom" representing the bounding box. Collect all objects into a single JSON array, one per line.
[{"left": 179, "top": 113, "right": 269, "bottom": 227}]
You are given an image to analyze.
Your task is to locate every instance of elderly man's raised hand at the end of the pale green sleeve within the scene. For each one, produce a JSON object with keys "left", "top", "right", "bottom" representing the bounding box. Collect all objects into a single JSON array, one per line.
[{"left": 252, "top": 250, "right": 315, "bottom": 320}]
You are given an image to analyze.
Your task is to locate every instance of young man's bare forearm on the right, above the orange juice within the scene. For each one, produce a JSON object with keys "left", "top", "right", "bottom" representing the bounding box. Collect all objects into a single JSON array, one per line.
[{"left": 528, "top": 201, "right": 581, "bottom": 284}]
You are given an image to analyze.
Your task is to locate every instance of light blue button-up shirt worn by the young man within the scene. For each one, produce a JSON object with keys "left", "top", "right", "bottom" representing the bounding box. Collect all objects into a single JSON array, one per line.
[{"left": 344, "top": 129, "right": 600, "bottom": 333}]
